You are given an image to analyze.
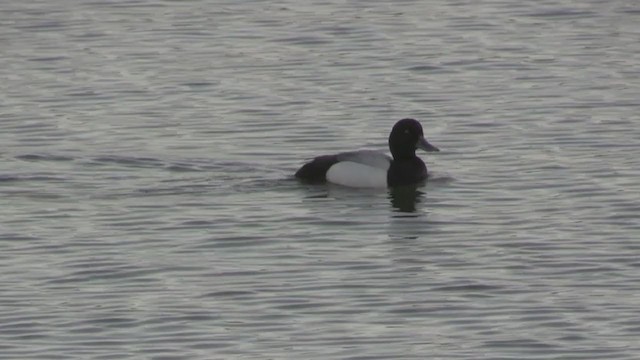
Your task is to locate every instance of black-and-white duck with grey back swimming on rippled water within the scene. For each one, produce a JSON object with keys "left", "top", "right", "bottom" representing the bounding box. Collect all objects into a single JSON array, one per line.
[{"left": 295, "top": 118, "right": 440, "bottom": 188}]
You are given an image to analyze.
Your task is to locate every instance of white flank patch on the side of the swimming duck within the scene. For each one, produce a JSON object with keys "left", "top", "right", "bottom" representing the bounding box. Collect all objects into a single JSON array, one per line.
[{"left": 327, "top": 161, "right": 387, "bottom": 188}]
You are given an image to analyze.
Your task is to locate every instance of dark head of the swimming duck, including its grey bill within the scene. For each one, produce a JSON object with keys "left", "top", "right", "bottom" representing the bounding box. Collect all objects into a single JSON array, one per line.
[{"left": 389, "top": 119, "right": 440, "bottom": 160}]
